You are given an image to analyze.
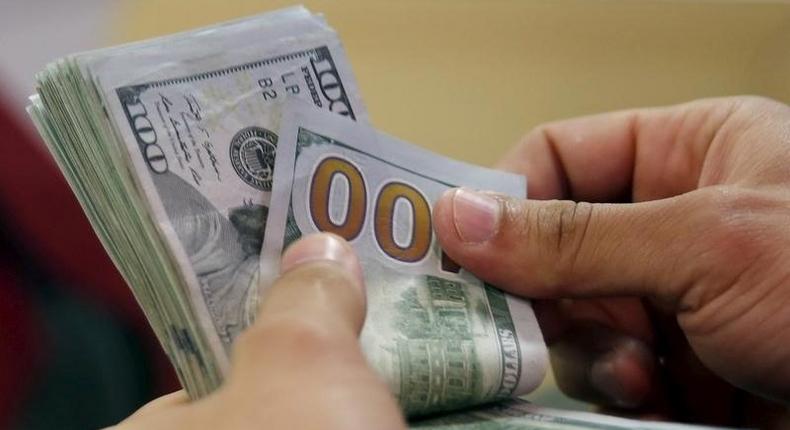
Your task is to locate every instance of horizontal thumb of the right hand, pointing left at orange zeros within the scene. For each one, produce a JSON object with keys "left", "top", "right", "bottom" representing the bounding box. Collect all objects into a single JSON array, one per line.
[{"left": 434, "top": 189, "right": 716, "bottom": 302}]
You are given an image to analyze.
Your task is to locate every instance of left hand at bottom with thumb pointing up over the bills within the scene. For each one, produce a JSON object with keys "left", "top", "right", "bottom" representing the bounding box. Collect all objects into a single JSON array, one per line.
[{"left": 117, "top": 234, "right": 405, "bottom": 430}]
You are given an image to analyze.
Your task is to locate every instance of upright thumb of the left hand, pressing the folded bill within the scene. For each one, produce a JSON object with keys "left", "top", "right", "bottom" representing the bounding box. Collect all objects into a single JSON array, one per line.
[{"left": 234, "top": 234, "right": 365, "bottom": 376}]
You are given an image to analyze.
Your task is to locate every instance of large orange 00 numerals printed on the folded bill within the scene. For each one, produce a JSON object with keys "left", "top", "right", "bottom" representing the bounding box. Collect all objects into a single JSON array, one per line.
[{"left": 309, "top": 157, "right": 432, "bottom": 263}]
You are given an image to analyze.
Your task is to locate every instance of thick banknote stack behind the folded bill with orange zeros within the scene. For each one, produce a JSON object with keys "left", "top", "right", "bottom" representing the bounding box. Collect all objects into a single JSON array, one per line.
[{"left": 28, "top": 7, "right": 366, "bottom": 397}]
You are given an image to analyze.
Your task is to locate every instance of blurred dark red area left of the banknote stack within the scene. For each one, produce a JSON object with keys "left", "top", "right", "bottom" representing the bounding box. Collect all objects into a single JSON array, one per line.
[{"left": 0, "top": 93, "right": 178, "bottom": 391}]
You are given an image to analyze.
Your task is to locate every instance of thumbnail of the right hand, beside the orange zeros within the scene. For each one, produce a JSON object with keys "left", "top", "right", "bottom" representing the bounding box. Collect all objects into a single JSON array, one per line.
[{"left": 452, "top": 188, "right": 501, "bottom": 243}]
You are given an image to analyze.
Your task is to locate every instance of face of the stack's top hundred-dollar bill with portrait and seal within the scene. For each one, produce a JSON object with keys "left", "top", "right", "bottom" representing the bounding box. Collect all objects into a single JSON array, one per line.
[{"left": 97, "top": 10, "right": 366, "bottom": 356}]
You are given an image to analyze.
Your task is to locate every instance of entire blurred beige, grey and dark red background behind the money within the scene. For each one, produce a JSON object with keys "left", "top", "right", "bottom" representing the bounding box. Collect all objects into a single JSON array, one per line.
[{"left": 0, "top": 0, "right": 790, "bottom": 429}]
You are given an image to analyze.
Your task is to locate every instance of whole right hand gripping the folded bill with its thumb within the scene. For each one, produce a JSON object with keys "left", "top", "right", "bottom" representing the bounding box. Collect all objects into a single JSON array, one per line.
[{"left": 434, "top": 97, "right": 790, "bottom": 425}]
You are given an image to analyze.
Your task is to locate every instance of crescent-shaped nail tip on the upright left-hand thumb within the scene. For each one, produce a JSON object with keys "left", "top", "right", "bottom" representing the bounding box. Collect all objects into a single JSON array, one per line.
[{"left": 280, "top": 233, "right": 362, "bottom": 284}]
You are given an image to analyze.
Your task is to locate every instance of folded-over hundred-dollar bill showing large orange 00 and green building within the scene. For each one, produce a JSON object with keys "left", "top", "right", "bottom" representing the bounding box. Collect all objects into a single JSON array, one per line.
[{"left": 261, "top": 100, "right": 547, "bottom": 415}]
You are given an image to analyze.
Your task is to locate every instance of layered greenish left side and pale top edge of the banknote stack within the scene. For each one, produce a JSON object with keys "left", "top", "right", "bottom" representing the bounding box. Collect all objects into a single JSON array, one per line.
[{"left": 28, "top": 7, "right": 364, "bottom": 397}]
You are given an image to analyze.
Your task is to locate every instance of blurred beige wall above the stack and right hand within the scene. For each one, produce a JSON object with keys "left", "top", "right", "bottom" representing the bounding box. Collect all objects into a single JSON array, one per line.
[{"left": 117, "top": 0, "right": 790, "bottom": 164}]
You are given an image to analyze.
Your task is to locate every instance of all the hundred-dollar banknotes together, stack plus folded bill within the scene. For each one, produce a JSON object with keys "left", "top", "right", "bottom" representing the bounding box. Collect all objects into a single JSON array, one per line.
[{"left": 28, "top": 7, "right": 736, "bottom": 428}]
